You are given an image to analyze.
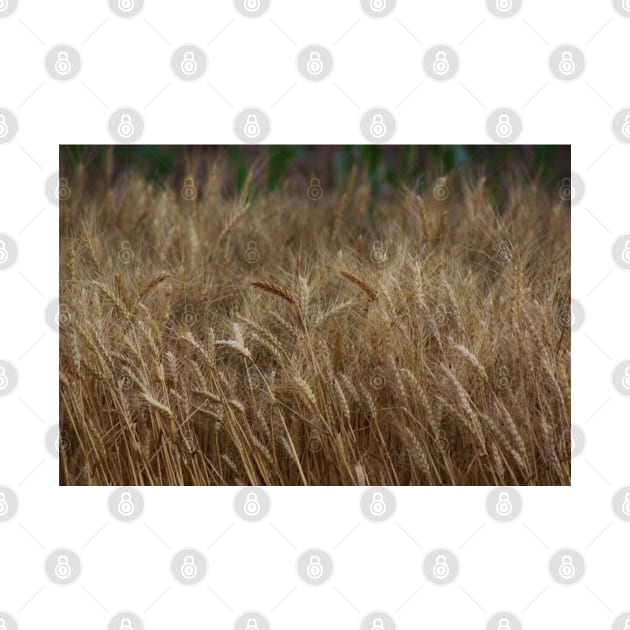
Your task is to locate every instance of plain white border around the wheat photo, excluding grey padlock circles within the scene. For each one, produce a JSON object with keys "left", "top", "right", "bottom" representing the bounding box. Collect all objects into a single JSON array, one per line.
[{"left": 0, "top": 0, "right": 630, "bottom": 630}]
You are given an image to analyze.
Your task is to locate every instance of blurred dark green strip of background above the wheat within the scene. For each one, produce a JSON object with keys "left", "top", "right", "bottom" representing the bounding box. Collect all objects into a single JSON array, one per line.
[{"left": 59, "top": 145, "right": 571, "bottom": 210}]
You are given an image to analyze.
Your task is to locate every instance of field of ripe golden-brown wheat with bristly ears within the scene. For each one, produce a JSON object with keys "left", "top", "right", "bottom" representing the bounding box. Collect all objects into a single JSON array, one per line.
[{"left": 59, "top": 153, "right": 571, "bottom": 485}]
